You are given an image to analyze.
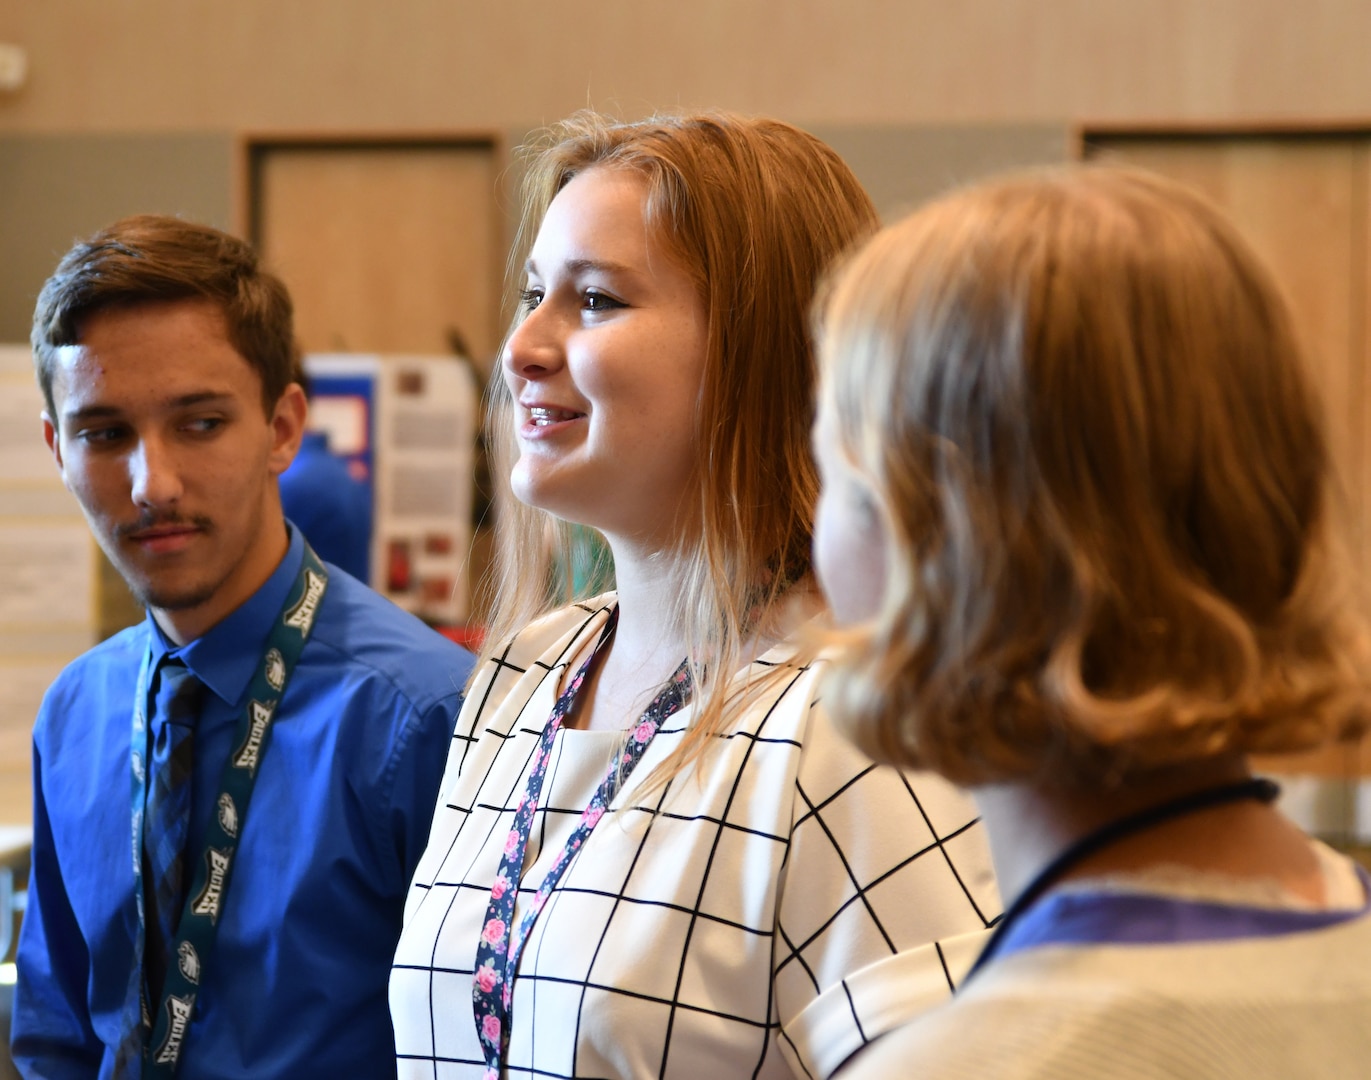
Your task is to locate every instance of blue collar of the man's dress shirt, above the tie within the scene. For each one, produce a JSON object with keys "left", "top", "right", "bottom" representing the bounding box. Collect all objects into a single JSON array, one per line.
[{"left": 148, "top": 522, "right": 304, "bottom": 706}]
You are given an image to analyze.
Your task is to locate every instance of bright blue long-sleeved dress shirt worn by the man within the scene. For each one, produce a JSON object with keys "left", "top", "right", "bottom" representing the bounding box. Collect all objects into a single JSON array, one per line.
[{"left": 11, "top": 529, "right": 472, "bottom": 1080}]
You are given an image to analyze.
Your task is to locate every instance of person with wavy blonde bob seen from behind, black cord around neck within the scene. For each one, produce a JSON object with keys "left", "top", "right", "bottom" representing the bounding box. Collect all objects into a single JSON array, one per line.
[{"left": 816, "top": 167, "right": 1371, "bottom": 1080}]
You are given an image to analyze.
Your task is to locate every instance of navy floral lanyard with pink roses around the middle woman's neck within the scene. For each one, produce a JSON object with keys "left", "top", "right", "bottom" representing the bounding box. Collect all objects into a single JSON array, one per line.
[{"left": 472, "top": 607, "right": 691, "bottom": 1080}]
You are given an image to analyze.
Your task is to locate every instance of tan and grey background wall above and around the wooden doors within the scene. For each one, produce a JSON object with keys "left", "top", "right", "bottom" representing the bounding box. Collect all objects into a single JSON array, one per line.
[{"left": 0, "top": 0, "right": 1371, "bottom": 344}]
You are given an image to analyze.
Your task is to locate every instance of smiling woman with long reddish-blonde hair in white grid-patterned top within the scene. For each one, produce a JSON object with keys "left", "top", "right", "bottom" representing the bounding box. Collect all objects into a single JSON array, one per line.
[{"left": 391, "top": 115, "right": 998, "bottom": 1080}]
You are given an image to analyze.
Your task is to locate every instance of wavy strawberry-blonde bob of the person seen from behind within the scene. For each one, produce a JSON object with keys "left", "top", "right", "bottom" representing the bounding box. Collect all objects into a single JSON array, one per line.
[{"left": 816, "top": 166, "right": 1371, "bottom": 788}]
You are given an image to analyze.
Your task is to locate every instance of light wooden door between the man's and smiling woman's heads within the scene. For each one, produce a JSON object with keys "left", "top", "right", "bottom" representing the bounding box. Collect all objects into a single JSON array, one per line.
[{"left": 247, "top": 140, "right": 505, "bottom": 369}]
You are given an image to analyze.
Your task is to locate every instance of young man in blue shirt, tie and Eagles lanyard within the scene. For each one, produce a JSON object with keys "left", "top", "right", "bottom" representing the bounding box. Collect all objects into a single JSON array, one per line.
[{"left": 12, "top": 217, "right": 472, "bottom": 1079}]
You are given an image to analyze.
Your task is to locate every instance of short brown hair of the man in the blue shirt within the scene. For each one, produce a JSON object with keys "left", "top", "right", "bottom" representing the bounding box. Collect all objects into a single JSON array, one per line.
[{"left": 30, "top": 214, "right": 295, "bottom": 415}]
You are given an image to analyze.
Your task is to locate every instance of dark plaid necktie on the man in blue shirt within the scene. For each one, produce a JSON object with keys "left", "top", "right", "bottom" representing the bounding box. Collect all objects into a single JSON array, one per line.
[{"left": 143, "top": 659, "right": 204, "bottom": 1010}]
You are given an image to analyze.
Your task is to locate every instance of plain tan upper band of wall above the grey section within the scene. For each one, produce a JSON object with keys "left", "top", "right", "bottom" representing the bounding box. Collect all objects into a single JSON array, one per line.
[{"left": 0, "top": 0, "right": 1371, "bottom": 132}]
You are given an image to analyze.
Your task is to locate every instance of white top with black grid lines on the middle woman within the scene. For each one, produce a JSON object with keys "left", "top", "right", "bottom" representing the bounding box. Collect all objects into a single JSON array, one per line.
[{"left": 391, "top": 596, "right": 998, "bottom": 1079}]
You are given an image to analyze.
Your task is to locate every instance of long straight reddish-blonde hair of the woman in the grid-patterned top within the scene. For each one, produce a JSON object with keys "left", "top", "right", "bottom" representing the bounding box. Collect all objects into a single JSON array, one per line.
[{"left": 477, "top": 112, "right": 877, "bottom": 778}]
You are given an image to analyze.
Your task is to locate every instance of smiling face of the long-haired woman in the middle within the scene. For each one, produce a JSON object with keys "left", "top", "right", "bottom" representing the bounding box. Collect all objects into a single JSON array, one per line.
[{"left": 503, "top": 167, "right": 707, "bottom": 555}]
